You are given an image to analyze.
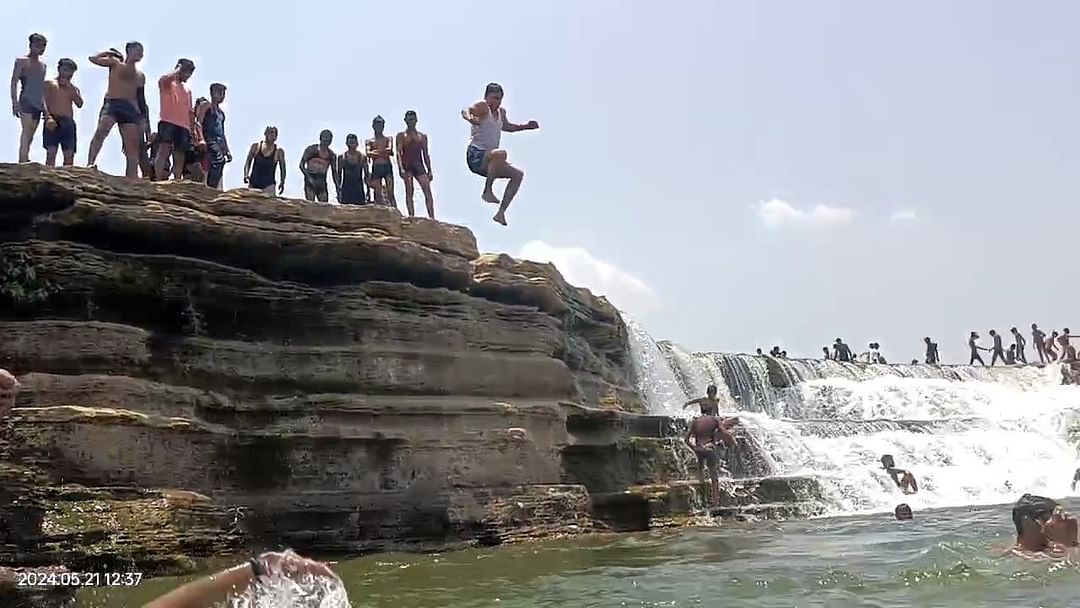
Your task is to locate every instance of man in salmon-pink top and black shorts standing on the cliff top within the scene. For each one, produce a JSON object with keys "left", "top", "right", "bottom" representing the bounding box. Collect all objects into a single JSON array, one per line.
[{"left": 153, "top": 57, "right": 195, "bottom": 181}]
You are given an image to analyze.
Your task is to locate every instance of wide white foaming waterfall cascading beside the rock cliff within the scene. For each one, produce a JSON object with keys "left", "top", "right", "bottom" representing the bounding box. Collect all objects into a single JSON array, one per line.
[{"left": 632, "top": 317, "right": 1080, "bottom": 514}]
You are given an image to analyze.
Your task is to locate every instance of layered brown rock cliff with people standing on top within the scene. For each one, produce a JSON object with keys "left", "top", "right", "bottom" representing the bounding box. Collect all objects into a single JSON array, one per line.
[{"left": 0, "top": 165, "right": 816, "bottom": 586}]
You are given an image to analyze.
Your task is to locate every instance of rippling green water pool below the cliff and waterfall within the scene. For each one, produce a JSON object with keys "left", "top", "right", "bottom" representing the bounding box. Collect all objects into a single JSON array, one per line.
[{"left": 79, "top": 503, "right": 1080, "bottom": 608}]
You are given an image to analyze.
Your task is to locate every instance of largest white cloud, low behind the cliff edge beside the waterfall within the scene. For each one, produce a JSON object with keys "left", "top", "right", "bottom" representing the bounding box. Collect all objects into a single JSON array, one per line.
[{"left": 517, "top": 241, "right": 660, "bottom": 316}]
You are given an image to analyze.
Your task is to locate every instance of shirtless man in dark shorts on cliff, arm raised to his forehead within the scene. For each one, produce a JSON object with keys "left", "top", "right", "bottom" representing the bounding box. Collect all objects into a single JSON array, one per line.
[{"left": 86, "top": 42, "right": 150, "bottom": 179}]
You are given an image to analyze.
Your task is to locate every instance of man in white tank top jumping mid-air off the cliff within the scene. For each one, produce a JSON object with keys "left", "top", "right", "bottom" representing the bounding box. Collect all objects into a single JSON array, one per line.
[{"left": 461, "top": 82, "right": 540, "bottom": 226}]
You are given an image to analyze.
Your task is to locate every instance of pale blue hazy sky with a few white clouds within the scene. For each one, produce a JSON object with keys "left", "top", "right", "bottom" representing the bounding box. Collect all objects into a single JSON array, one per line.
[{"left": 0, "top": 0, "right": 1080, "bottom": 362}]
